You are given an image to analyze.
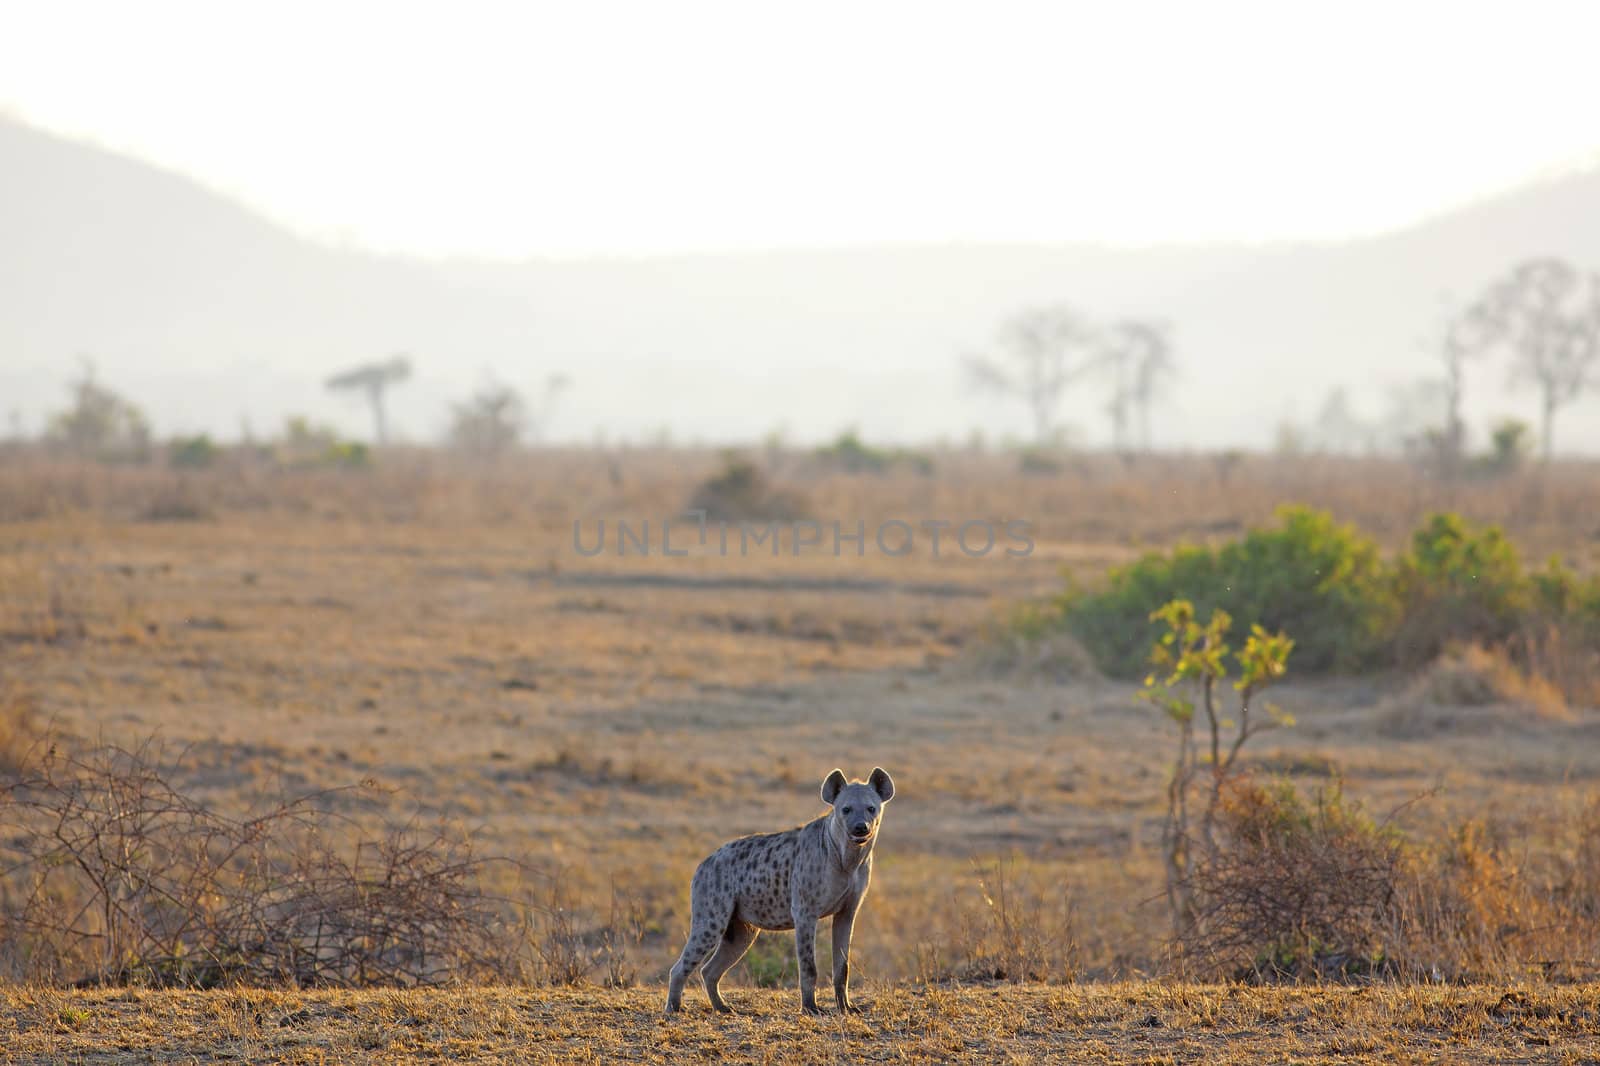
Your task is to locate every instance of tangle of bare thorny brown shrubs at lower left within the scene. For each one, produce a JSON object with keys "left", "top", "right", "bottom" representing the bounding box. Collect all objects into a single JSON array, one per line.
[{"left": 0, "top": 741, "right": 510, "bottom": 988}]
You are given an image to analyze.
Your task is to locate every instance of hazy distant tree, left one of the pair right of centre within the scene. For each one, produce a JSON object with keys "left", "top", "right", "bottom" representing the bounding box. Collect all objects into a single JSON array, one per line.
[{"left": 965, "top": 306, "right": 1101, "bottom": 445}]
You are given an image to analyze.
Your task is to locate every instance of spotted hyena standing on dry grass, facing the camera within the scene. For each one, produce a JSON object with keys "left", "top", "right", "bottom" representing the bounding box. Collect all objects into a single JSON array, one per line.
[{"left": 667, "top": 768, "right": 894, "bottom": 1013}]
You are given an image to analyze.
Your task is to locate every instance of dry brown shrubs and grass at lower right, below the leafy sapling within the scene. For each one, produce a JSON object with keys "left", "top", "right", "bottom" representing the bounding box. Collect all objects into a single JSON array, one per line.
[{"left": 1179, "top": 781, "right": 1600, "bottom": 981}]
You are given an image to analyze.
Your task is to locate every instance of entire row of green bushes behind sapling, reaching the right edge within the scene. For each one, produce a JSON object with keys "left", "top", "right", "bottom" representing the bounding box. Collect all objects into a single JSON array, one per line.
[{"left": 1049, "top": 507, "right": 1600, "bottom": 677}]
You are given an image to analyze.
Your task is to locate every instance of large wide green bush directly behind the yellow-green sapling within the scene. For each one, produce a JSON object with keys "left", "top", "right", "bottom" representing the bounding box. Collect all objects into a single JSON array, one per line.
[{"left": 1062, "top": 507, "right": 1395, "bottom": 677}]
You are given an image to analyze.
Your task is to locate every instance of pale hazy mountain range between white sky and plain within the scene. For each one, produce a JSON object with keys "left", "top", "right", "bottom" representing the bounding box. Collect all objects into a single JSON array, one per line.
[{"left": 0, "top": 120, "right": 1600, "bottom": 451}]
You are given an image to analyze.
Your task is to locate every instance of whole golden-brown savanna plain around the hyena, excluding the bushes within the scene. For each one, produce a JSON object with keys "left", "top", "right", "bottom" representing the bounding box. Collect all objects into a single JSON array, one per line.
[{"left": 0, "top": 450, "right": 1600, "bottom": 1063}]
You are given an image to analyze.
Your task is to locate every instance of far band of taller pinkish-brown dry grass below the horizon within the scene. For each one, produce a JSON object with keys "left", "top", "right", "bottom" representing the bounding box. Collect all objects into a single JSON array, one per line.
[{"left": 0, "top": 447, "right": 1600, "bottom": 570}]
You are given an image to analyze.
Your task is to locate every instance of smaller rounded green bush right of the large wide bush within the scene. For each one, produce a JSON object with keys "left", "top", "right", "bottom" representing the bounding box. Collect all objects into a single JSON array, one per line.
[{"left": 1395, "top": 514, "right": 1516, "bottom": 664}]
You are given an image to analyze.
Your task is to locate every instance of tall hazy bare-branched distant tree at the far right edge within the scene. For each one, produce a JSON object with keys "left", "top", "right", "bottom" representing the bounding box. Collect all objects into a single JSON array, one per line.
[{"left": 1467, "top": 259, "right": 1600, "bottom": 461}]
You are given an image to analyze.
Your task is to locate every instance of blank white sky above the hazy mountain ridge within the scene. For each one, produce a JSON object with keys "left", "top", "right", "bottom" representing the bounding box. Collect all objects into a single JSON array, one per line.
[{"left": 0, "top": 0, "right": 1600, "bottom": 258}]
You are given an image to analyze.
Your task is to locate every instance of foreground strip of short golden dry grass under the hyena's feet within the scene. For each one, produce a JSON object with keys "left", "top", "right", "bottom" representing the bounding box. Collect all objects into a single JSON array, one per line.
[{"left": 0, "top": 983, "right": 1600, "bottom": 1064}]
